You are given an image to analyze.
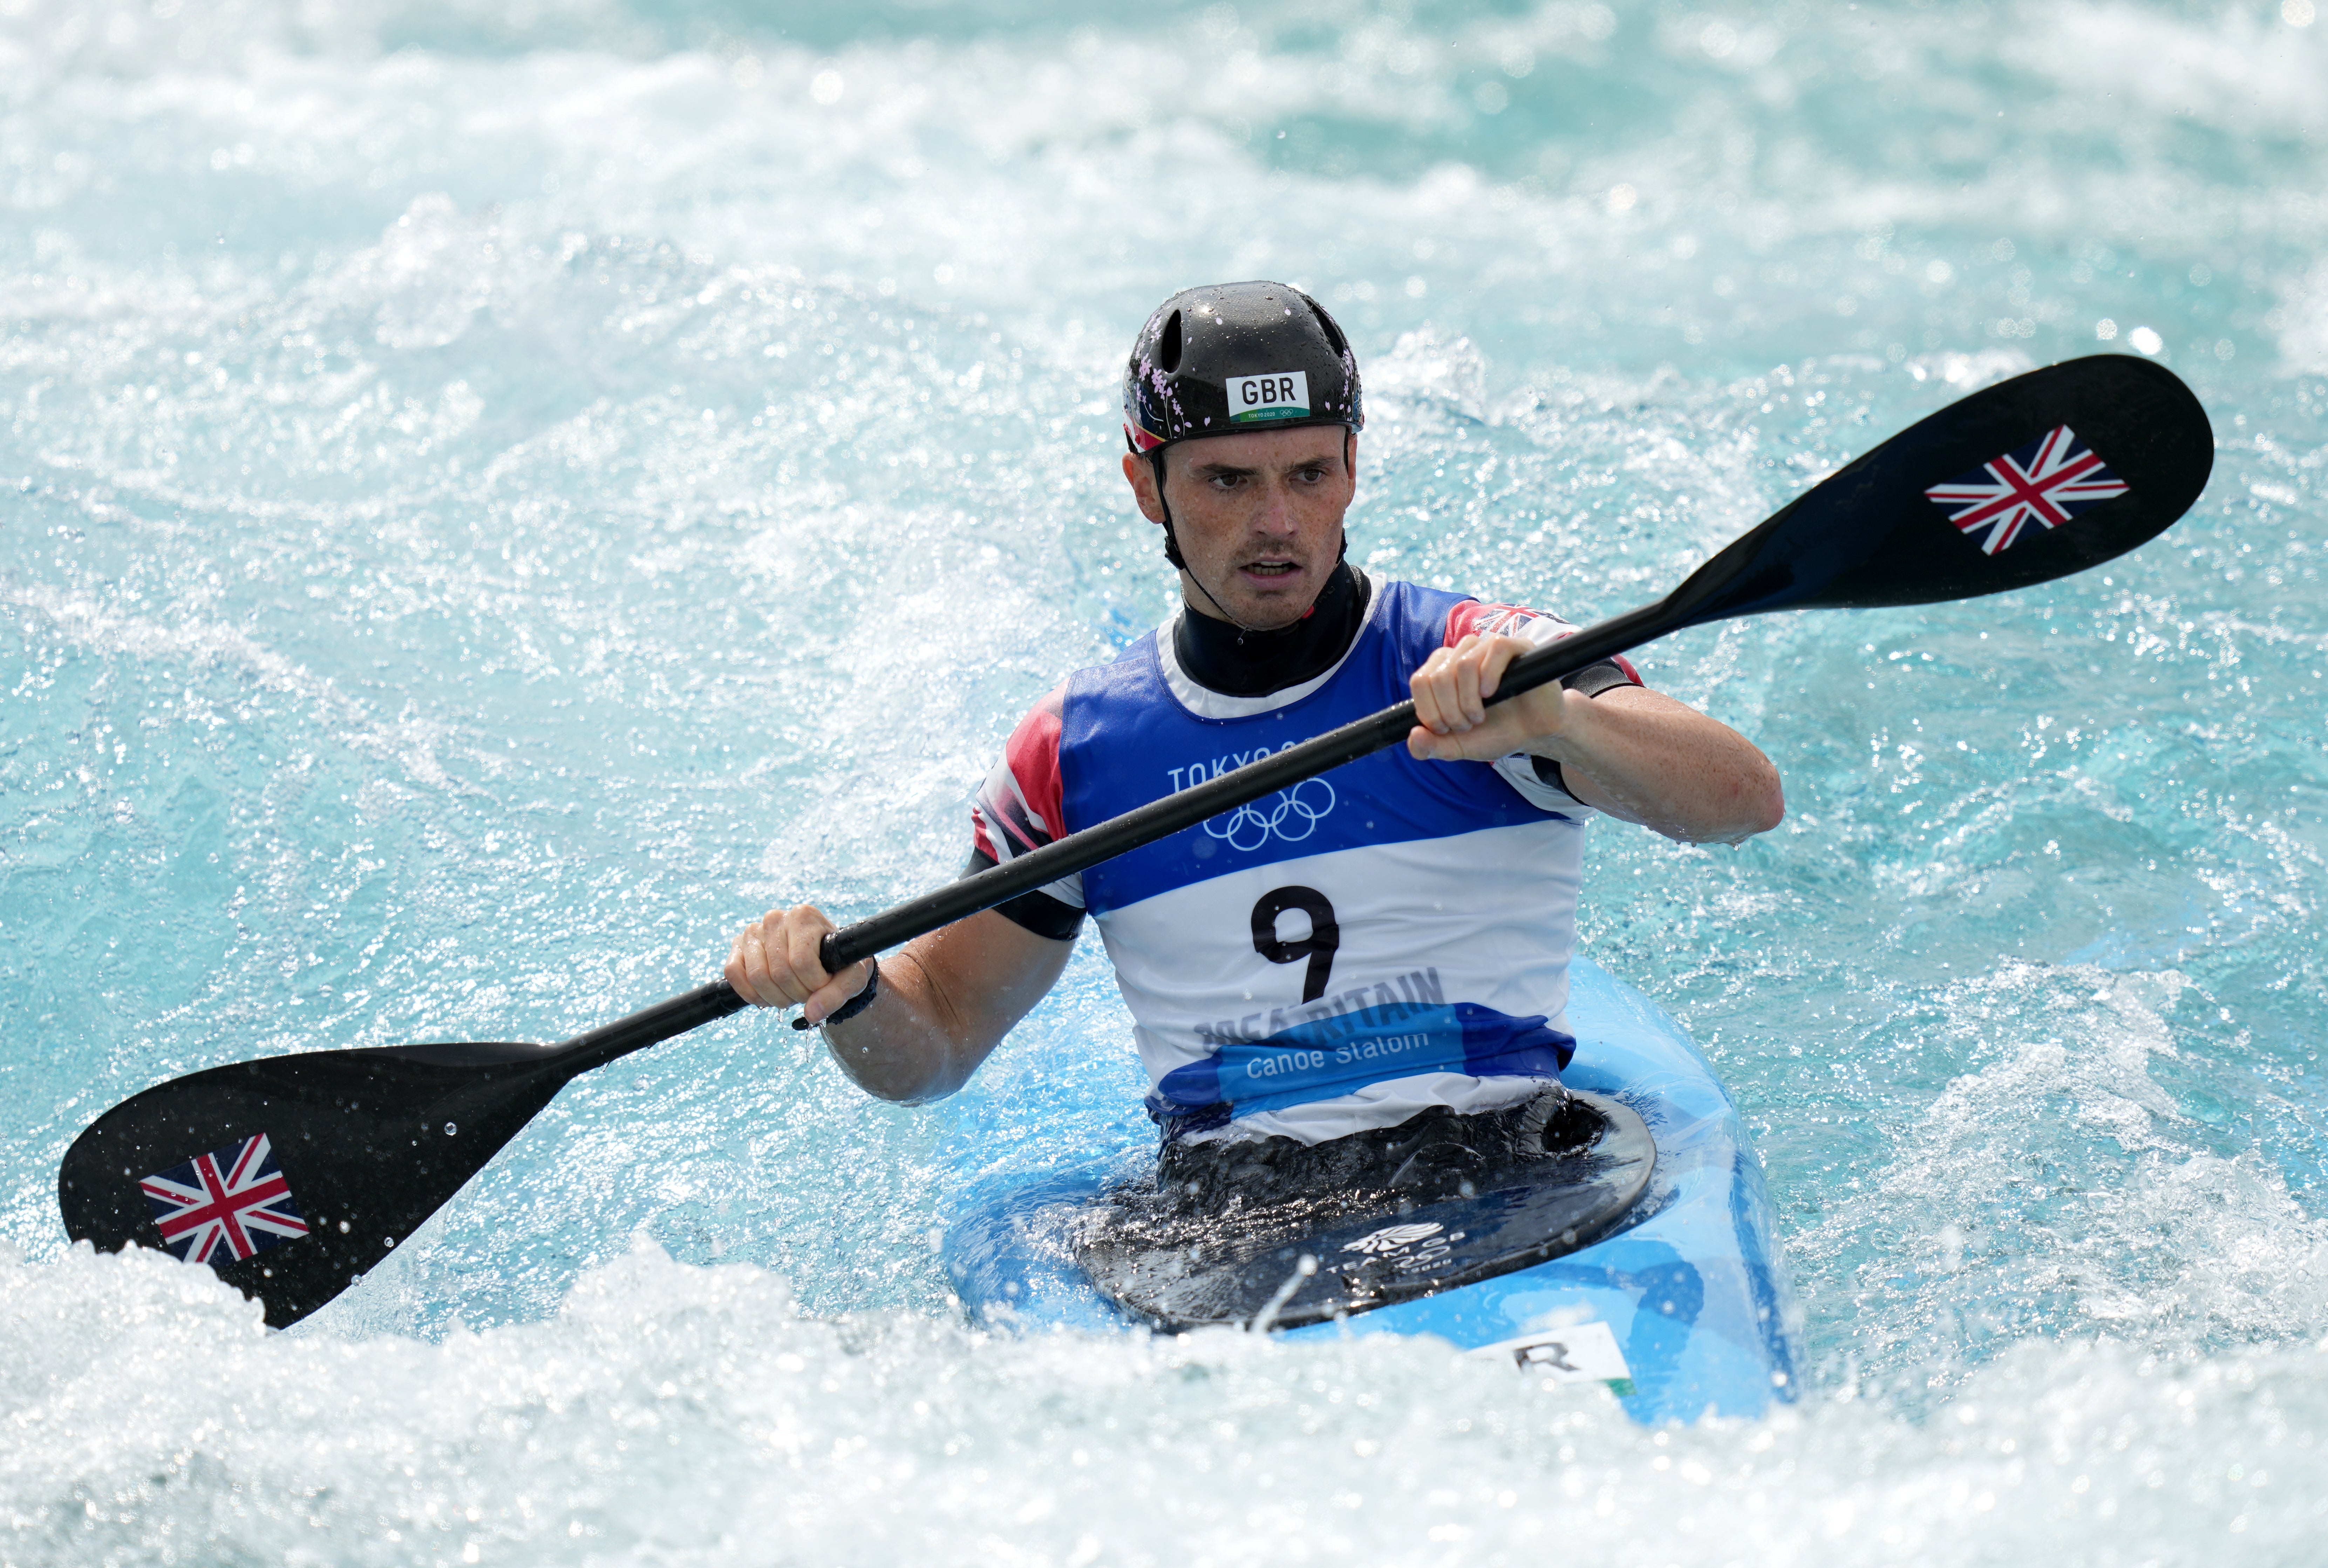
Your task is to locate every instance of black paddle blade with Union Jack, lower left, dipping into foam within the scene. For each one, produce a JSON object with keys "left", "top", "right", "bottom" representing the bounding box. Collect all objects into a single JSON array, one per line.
[{"left": 56, "top": 1044, "right": 580, "bottom": 1328}]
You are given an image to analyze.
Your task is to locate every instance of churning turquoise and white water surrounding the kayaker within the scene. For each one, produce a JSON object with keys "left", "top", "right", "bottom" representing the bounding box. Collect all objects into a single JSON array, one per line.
[{"left": 0, "top": 0, "right": 2328, "bottom": 1563}]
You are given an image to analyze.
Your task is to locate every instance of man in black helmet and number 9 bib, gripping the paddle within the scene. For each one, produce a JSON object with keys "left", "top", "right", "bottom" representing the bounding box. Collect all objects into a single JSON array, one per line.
[{"left": 726, "top": 284, "right": 1783, "bottom": 1191}]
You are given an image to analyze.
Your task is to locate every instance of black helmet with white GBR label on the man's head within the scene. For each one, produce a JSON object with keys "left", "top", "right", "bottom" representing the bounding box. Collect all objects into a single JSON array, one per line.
[{"left": 1124, "top": 284, "right": 1367, "bottom": 451}]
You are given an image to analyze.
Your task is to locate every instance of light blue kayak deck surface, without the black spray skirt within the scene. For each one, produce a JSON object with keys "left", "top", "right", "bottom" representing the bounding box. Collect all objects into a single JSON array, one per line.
[{"left": 940, "top": 959, "right": 1797, "bottom": 1424}]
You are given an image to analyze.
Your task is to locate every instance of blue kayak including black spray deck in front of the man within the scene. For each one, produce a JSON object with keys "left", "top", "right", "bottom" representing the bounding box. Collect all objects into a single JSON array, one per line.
[{"left": 940, "top": 959, "right": 1797, "bottom": 1424}]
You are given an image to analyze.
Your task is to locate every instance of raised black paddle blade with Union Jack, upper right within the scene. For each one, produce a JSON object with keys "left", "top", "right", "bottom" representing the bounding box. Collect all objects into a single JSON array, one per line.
[{"left": 1660, "top": 354, "right": 2214, "bottom": 626}]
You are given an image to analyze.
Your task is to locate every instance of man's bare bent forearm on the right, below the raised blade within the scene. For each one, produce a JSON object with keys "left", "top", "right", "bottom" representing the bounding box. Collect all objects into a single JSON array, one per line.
[{"left": 1530, "top": 686, "right": 1785, "bottom": 845}]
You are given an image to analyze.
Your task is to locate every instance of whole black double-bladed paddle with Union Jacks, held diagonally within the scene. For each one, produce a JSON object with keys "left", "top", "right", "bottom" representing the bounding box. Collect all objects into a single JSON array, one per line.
[{"left": 58, "top": 356, "right": 2214, "bottom": 1326}]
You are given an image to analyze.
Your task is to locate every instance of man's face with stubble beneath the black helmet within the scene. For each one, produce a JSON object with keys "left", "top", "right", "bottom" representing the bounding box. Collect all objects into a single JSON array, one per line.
[{"left": 1124, "top": 426, "right": 1357, "bottom": 630}]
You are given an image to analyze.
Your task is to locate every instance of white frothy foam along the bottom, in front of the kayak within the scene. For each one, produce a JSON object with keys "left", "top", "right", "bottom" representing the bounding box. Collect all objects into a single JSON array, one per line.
[{"left": 0, "top": 1245, "right": 2328, "bottom": 1563}]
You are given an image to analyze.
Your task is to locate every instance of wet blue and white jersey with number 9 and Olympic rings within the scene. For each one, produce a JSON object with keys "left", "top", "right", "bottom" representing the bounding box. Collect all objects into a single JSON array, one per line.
[{"left": 973, "top": 567, "right": 1636, "bottom": 1142}]
